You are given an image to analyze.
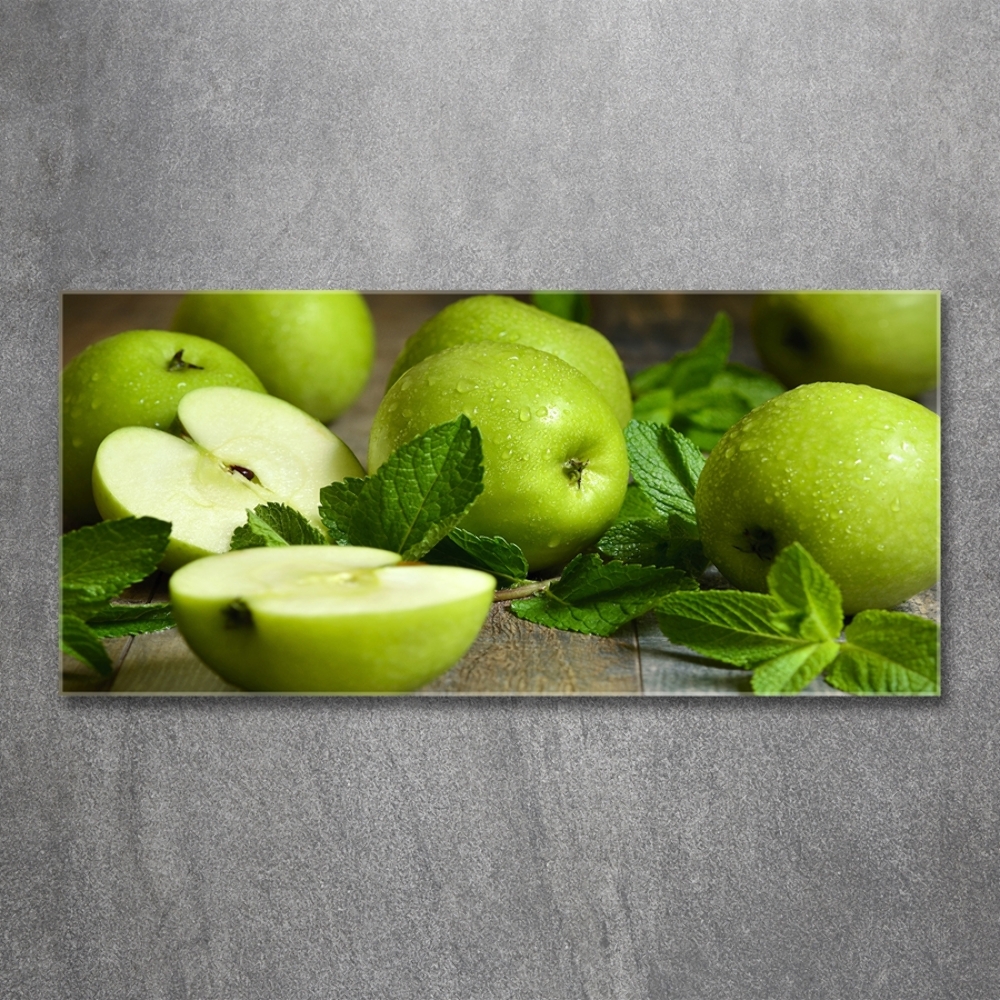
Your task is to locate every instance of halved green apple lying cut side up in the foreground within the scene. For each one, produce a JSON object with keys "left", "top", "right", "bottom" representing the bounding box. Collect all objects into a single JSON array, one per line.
[{"left": 170, "top": 545, "right": 496, "bottom": 694}]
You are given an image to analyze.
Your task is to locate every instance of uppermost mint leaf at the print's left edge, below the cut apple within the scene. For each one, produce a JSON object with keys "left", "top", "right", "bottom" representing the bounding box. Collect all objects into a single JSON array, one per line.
[{"left": 61, "top": 517, "right": 170, "bottom": 620}]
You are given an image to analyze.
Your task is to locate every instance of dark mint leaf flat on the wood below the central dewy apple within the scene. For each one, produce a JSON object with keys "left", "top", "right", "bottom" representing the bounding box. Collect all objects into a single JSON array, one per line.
[{"left": 511, "top": 553, "right": 697, "bottom": 636}]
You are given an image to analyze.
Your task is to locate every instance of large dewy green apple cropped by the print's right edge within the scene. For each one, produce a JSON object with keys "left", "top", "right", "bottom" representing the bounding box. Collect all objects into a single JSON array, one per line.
[{"left": 694, "top": 382, "right": 940, "bottom": 614}]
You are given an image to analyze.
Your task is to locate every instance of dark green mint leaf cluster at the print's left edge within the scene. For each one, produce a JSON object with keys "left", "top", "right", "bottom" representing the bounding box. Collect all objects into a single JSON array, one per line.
[{"left": 59, "top": 517, "right": 174, "bottom": 676}]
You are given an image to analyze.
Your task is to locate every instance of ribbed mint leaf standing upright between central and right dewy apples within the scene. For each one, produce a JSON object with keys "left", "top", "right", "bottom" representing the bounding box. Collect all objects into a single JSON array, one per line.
[{"left": 625, "top": 420, "right": 705, "bottom": 537}]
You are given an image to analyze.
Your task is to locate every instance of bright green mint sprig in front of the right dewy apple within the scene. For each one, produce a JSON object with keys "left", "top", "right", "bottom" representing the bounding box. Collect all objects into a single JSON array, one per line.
[{"left": 657, "top": 542, "right": 940, "bottom": 695}]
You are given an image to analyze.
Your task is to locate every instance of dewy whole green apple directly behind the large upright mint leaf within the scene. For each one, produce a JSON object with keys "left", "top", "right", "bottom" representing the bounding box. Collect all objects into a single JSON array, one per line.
[{"left": 368, "top": 341, "right": 628, "bottom": 569}]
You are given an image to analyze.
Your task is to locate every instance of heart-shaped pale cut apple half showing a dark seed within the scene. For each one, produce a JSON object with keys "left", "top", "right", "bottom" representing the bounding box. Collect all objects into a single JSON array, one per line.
[{"left": 94, "top": 388, "right": 364, "bottom": 569}]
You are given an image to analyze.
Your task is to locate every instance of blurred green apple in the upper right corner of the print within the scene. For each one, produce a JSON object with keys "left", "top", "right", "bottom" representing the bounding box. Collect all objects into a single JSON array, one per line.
[{"left": 750, "top": 292, "right": 941, "bottom": 397}]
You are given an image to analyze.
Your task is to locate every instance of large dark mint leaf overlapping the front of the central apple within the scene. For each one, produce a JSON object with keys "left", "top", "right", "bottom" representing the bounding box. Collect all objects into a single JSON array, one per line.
[{"left": 332, "top": 415, "right": 483, "bottom": 559}]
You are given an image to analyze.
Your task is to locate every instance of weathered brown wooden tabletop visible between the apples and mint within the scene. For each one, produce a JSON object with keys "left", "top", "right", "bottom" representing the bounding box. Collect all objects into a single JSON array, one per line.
[{"left": 62, "top": 293, "right": 938, "bottom": 697}]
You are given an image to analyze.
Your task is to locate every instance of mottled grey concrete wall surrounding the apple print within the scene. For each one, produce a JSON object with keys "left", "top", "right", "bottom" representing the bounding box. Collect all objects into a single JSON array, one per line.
[{"left": 0, "top": 0, "right": 1000, "bottom": 1000}]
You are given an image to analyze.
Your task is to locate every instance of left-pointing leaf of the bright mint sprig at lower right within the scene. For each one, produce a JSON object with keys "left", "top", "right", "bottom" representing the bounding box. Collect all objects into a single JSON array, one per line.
[{"left": 656, "top": 590, "right": 804, "bottom": 667}]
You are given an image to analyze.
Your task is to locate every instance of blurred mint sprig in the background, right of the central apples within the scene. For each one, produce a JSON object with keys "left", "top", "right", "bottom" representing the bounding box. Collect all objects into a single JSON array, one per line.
[{"left": 631, "top": 312, "right": 784, "bottom": 451}]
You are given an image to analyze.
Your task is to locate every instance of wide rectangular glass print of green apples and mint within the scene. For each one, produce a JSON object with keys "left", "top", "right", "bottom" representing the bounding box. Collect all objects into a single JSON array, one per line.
[{"left": 60, "top": 291, "right": 940, "bottom": 698}]
